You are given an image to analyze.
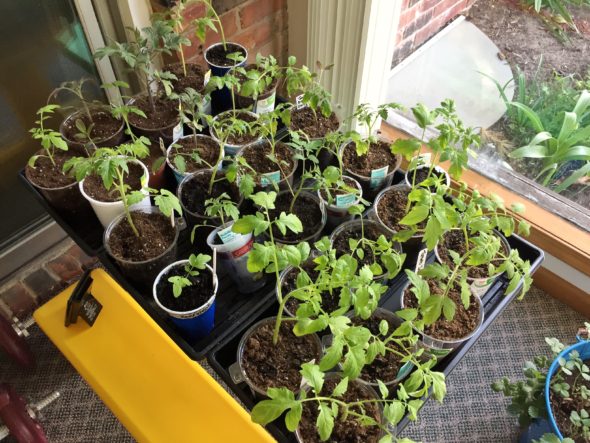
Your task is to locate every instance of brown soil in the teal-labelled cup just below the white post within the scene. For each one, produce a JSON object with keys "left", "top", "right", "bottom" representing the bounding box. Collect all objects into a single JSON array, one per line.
[{"left": 342, "top": 141, "right": 401, "bottom": 177}]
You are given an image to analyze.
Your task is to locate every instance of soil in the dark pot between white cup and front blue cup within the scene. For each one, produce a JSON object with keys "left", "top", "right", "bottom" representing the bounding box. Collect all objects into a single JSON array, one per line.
[{"left": 109, "top": 211, "right": 176, "bottom": 262}]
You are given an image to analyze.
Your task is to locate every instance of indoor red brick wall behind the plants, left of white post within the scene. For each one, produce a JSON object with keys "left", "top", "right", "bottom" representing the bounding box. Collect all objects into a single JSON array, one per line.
[{"left": 185, "top": 0, "right": 289, "bottom": 64}]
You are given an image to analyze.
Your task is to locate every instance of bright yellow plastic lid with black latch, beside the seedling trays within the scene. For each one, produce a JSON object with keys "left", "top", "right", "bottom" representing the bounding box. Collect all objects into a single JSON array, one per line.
[{"left": 34, "top": 269, "right": 274, "bottom": 443}]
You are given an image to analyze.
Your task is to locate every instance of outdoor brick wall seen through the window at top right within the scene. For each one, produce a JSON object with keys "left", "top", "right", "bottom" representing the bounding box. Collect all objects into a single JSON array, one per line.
[{"left": 391, "top": 0, "right": 475, "bottom": 67}]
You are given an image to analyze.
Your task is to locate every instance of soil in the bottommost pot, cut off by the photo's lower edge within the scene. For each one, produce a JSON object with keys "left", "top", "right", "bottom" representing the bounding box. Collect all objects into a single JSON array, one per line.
[{"left": 299, "top": 379, "right": 381, "bottom": 443}]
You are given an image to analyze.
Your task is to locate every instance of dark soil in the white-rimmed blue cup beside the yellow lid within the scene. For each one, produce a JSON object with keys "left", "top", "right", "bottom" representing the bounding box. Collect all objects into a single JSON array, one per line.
[{"left": 157, "top": 266, "right": 213, "bottom": 312}]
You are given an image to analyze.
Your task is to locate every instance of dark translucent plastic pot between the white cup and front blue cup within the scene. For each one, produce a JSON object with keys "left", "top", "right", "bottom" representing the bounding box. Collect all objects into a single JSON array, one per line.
[{"left": 103, "top": 206, "right": 185, "bottom": 290}]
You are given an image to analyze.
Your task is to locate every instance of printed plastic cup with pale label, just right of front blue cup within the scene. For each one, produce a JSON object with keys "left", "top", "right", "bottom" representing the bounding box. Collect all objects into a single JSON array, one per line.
[{"left": 207, "top": 222, "right": 266, "bottom": 294}]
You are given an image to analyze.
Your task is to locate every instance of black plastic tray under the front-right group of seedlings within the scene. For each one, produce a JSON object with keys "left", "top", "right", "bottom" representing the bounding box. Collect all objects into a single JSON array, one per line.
[{"left": 207, "top": 236, "right": 544, "bottom": 442}]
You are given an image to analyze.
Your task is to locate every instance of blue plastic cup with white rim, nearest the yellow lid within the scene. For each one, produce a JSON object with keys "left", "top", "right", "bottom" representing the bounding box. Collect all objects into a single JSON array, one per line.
[{"left": 153, "top": 260, "right": 218, "bottom": 342}]
